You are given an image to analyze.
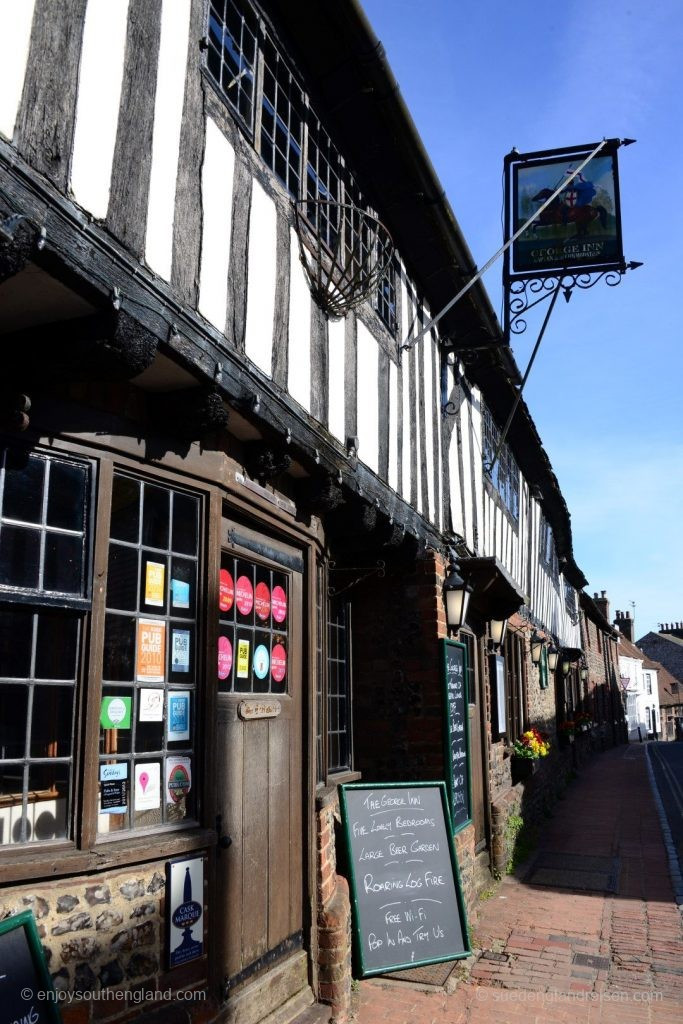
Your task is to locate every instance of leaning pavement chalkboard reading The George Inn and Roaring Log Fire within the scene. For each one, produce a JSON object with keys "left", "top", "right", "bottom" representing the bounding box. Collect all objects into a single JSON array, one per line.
[{"left": 340, "top": 782, "right": 470, "bottom": 977}]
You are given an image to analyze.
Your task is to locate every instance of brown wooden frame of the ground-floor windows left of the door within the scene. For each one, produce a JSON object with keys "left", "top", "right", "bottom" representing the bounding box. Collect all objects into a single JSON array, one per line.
[{"left": 0, "top": 439, "right": 210, "bottom": 860}]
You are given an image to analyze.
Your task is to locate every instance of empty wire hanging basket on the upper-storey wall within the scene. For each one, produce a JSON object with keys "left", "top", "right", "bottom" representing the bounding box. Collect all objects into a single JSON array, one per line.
[{"left": 295, "top": 199, "right": 394, "bottom": 318}]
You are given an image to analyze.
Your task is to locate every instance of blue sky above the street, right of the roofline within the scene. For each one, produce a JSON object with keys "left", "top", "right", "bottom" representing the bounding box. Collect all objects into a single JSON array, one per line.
[{"left": 364, "top": 0, "right": 683, "bottom": 637}]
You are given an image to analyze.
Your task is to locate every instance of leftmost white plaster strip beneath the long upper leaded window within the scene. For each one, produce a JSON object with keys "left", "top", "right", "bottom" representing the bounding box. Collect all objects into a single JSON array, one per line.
[{"left": 199, "top": 118, "right": 234, "bottom": 334}]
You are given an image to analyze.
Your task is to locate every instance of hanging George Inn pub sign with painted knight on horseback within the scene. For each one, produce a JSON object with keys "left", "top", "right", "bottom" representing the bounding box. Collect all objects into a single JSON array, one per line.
[{"left": 505, "top": 140, "right": 624, "bottom": 279}]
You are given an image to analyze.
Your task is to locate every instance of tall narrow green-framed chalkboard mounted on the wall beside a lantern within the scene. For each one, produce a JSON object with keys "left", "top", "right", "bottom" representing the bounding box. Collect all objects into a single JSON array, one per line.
[{"left": 441, "top": 640, "right": 472, "bottom": 836}]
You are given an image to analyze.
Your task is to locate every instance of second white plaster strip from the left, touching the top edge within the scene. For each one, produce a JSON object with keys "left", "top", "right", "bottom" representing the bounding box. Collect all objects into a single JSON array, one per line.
[{"left": 71, "top": 0, "right": 128, "bottom": 219}]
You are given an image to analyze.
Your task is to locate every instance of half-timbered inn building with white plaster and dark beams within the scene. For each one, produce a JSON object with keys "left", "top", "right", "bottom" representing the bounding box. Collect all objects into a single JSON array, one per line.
[{"left": 0, "top": 0, "right": 626, "bottom": 1024}]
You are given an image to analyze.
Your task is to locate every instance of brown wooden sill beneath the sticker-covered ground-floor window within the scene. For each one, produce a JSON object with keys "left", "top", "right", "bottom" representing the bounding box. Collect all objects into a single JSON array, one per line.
[{"left": 0, "top": 828, "right": 216, "bottom": 885}]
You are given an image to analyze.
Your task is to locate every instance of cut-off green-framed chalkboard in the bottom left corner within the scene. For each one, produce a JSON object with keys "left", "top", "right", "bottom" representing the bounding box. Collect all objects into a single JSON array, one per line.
[{"left": 0, "top": 910, "right": 61, "bottom": 1024}]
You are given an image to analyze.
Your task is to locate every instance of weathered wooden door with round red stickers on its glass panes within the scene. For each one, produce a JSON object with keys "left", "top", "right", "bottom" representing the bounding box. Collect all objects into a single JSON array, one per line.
[{"left": 213, "top": 519, "right": 306, "bottom": 1020}]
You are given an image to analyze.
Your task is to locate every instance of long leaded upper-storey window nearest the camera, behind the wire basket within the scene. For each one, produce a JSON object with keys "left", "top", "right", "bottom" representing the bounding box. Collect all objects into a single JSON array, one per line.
[{"left": 207, "top": 0, "right": 397, "bottom": 335}]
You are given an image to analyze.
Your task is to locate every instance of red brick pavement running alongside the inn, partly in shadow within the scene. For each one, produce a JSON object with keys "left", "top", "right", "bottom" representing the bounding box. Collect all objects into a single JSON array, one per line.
[{"left": 355, "top": 744, "right": 683, "bottom": 1024}]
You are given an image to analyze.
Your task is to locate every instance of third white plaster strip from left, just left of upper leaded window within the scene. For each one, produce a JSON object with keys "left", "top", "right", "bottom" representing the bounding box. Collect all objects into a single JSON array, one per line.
[{"left": 144, "top": 0, "right": 190, "bottom": 281}]
